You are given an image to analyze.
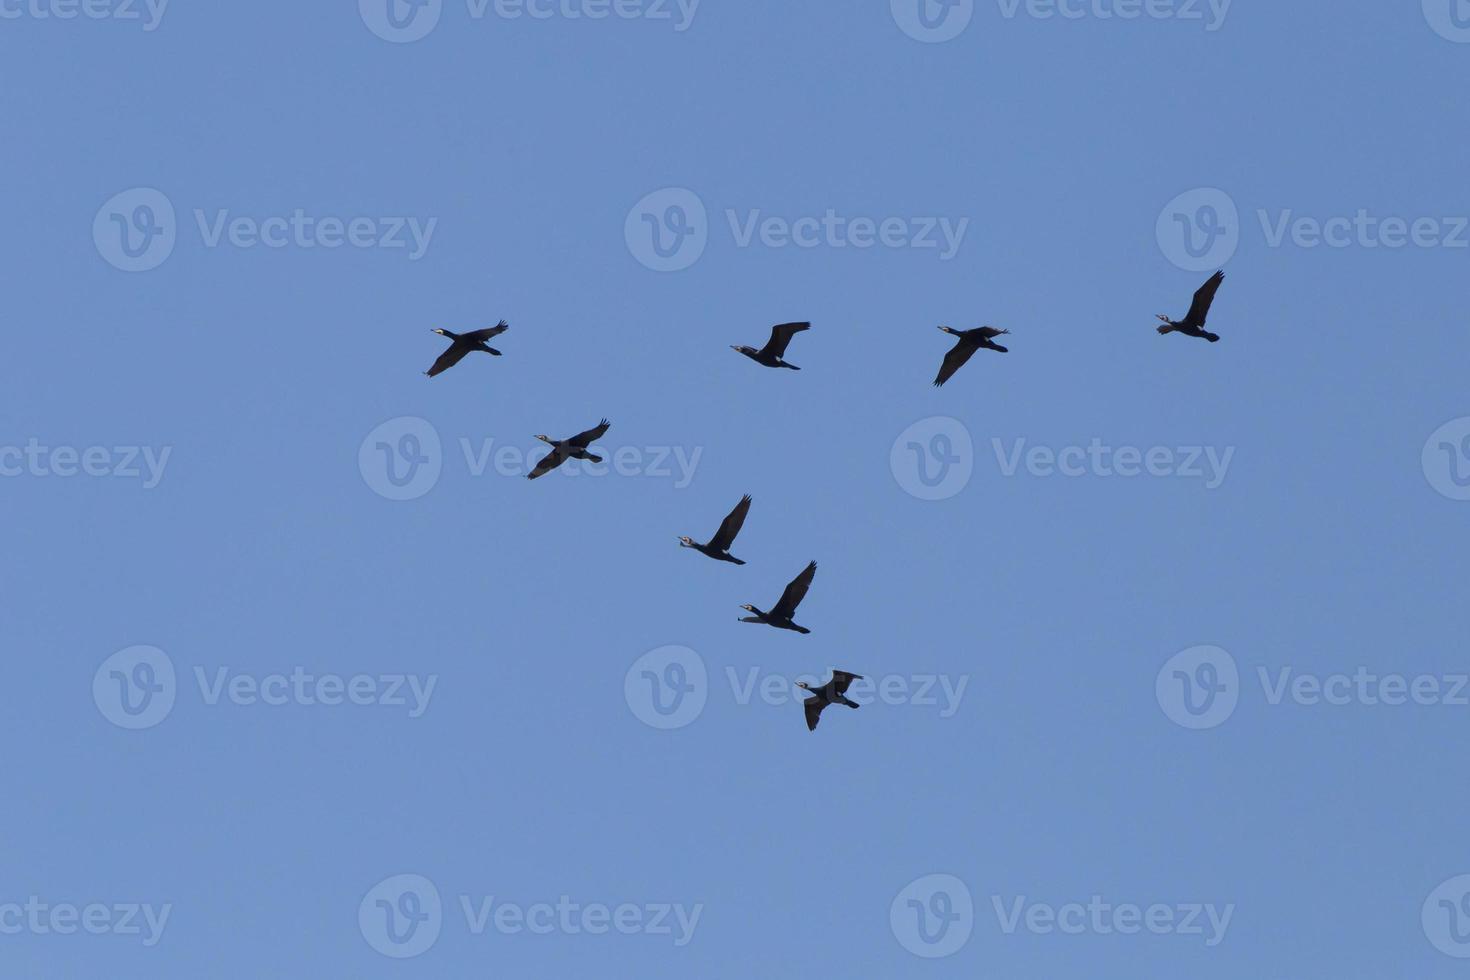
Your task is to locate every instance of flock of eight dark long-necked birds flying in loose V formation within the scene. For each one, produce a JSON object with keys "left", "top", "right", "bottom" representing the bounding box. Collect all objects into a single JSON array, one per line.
[{"left": 425, "top": 272, "right": 1225, "bottom": 730}]
